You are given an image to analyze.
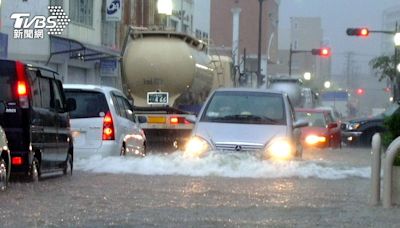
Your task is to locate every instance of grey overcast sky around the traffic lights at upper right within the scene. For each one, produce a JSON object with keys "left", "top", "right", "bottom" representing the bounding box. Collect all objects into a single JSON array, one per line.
[{"left": 279, "top": 0, "right": 400, "bottom": 74}]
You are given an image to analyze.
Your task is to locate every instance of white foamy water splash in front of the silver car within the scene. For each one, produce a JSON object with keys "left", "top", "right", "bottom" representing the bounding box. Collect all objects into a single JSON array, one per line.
[{"left": 75, "top": 152, "right": 370, "bottom": 179}]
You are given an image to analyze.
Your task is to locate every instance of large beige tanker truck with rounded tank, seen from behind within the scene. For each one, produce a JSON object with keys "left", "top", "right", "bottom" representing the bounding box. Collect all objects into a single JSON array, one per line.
[{"left": 121, "top": 28, "right": 231, "bottom": 150}]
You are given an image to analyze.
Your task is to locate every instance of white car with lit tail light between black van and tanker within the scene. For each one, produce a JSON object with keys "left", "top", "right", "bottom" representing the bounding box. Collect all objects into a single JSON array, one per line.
[{"left": 64, "top": 84, "right": 146, "bottom": 157}]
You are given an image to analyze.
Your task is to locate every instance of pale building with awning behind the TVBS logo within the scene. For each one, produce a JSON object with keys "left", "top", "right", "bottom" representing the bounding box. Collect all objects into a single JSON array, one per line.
[{"left": 1, "top": 0, "right": 122, "bottom": 88}]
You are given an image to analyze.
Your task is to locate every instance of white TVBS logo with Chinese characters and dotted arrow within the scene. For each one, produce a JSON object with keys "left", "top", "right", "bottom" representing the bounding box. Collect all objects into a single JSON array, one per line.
[{"left": 11, "top": 6, "right": 71, "bottom": 39}]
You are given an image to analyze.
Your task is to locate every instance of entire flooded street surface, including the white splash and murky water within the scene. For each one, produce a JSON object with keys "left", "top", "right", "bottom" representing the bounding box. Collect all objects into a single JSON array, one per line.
[{"left": 0, "top": 148, "right": 400, "bottom": 227}]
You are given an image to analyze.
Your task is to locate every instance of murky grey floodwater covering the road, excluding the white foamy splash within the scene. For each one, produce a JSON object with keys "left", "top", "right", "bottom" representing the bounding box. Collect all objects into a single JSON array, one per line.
[{"left": 0, "top": 148, "right": 400, "bottom": 227}]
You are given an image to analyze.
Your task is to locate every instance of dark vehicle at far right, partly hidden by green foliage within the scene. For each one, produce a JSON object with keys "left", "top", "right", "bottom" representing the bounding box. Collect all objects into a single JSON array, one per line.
[{"left": 341, "top": 102, "right": 400, "bottom": 146}]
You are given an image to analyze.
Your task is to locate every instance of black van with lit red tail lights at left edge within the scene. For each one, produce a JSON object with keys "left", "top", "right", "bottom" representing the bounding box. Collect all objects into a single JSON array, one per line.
[{"left": 0, "top": 60, "right": 76, "bottom": 181}]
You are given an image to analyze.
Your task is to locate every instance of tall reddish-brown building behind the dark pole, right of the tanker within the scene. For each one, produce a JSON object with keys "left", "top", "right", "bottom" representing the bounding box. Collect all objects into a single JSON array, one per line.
[{"left": 210, "top": 0, "right": 280, "bottom": 86}]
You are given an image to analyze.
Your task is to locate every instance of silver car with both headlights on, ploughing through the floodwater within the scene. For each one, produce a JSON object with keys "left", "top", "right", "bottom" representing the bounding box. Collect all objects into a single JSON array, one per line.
[{"left": 185, "top": 88, "right": 307, "bottom": 159}]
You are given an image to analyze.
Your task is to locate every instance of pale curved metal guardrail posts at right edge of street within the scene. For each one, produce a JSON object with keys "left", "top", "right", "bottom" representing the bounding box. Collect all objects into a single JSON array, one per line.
[{"left": 370, "top": 133, "right": 400, "bottom": 208}]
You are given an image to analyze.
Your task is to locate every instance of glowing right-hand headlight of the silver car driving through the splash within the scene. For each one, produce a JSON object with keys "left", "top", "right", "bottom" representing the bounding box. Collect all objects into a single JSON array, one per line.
[{"left": 264, "top": 138, "right": 295, "bottom": 160}]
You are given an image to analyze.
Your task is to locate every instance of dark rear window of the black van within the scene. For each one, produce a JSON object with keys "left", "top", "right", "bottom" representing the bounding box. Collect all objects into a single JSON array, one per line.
[{"left": 0, "top": 60, "right": 16, "bottom": 101}]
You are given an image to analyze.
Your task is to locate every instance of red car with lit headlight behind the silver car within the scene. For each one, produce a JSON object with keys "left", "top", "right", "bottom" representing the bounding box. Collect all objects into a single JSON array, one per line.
[{"left": 296, "top": 108, "right": 342, "bottom": 148}]
